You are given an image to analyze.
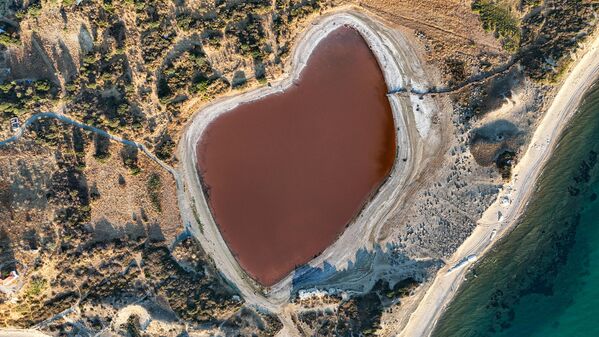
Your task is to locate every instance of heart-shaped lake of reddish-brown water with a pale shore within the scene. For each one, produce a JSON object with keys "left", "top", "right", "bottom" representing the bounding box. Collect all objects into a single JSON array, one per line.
[{"left": 197, "top": 27, "right": 396, "bottom": 286}]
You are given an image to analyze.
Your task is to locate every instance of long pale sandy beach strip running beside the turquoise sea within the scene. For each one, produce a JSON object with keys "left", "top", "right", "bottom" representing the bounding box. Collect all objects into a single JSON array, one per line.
[{"left": 400, "top": 32, "right": 599, "bottom": 337}]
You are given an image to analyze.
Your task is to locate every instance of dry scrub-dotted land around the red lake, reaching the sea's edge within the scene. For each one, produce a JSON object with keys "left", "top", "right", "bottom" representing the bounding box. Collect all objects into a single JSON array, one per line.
[{"left": 0, "top": 0, "right": 599, "bottom": 337}]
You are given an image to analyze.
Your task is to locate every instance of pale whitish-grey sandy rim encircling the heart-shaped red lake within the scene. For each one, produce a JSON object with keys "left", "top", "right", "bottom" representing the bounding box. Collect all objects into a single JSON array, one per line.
[{"left": 179, "top": 8, "right": 439, "bottom": 318}]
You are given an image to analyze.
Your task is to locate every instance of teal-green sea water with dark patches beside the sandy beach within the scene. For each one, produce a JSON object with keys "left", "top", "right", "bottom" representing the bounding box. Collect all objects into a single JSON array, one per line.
[{"left": 433, "top": 84, "right": 599, "bottom": 337}]
